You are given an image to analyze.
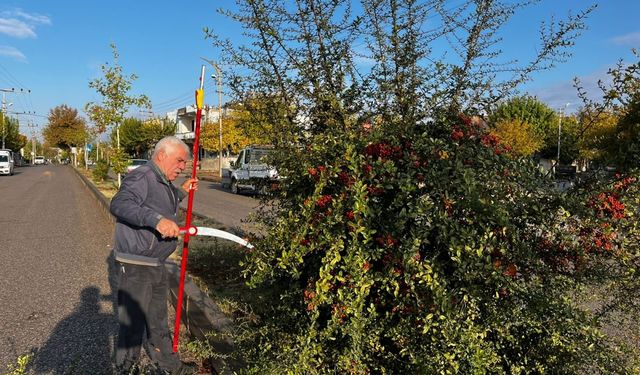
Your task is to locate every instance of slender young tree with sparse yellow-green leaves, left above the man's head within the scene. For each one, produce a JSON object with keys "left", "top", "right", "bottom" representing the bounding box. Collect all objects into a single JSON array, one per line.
[{"left": 85, "top": 43, "right": 151, "bottom": 179}]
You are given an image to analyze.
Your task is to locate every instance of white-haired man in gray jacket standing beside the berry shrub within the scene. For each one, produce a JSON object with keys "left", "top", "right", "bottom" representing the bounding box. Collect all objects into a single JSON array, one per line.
[{"left": 110, "top": 137, "right": 197, "bottom": 374}]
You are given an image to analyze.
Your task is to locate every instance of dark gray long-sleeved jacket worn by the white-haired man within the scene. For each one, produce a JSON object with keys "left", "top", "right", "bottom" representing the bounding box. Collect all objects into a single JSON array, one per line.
[{"left": 110, "top": 161, "right": 186, "bottom": 266}]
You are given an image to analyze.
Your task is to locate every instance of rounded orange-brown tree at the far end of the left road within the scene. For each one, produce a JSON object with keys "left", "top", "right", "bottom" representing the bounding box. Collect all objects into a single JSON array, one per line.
[{"left": 42, "top": 104, "right": 87, "bottom": 150}]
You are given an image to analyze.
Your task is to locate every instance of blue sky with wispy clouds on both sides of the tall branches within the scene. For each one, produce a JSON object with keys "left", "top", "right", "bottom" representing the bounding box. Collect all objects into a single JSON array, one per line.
[{"left": 0, "top": 0, "right": 640, "bottom": 133}]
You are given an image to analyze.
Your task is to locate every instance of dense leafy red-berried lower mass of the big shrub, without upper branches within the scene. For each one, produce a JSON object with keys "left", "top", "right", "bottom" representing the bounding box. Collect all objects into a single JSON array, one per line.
[{"left": 232, "top": 117, "right": 638, "bottom": 374}]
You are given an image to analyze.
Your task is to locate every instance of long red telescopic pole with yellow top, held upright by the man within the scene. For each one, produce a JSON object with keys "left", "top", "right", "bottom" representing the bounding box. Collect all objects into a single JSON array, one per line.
[{"left": 173, "top": 65, "right": 204, "bottom": 353}]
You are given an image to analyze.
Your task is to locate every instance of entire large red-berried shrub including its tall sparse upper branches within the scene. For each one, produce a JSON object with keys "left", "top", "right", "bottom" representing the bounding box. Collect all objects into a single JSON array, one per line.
[{"left": 205, "top": 0, "right": 637, "bottom": 374}]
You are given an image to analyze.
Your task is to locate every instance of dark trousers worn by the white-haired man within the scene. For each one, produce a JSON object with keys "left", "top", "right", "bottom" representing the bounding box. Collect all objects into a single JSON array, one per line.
[{"left": 115, "top": 263, "right": 181, "bottom": 372}]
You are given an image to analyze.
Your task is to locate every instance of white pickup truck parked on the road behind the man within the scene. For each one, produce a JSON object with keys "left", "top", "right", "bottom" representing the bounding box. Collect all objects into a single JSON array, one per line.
[{"left": 223, "top": 146, "right": 278, "bottom": 194}]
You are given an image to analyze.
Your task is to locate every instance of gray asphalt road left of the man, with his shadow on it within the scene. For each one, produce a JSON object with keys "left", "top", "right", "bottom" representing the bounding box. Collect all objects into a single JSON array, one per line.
[{"left": 0, "top": 165, "right": 117, "bottom": 374}]
